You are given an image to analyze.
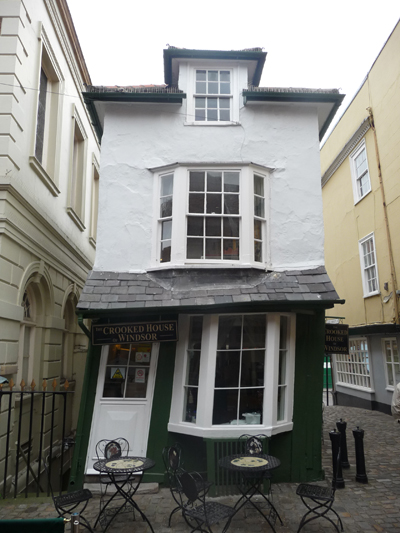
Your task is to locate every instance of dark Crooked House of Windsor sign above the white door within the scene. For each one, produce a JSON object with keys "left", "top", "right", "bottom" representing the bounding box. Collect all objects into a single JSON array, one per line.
[{"left": 92, "top": 320, "right": 178, "bottom": 345}]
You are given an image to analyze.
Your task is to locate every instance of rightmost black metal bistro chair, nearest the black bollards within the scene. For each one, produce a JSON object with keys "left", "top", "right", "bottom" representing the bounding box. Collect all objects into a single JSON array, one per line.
[{"left": 296, "top": 448, "right": 343, "bottom": 533}]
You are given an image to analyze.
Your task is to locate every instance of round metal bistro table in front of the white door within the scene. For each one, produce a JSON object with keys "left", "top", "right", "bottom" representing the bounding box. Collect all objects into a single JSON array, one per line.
[{"left": 93, "top": 456, "right": 155, "bottom": 533}]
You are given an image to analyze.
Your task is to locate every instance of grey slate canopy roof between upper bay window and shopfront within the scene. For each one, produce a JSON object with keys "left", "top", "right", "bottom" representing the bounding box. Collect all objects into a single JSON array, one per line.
[{"left": 77, "top": 267, "right": 339, "bottom": 311}]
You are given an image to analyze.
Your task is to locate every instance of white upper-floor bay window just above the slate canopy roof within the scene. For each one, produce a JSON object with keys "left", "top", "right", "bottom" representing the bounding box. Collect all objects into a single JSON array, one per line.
[{"left": 154, "top": 165, "right": 268, "bottom": 267}]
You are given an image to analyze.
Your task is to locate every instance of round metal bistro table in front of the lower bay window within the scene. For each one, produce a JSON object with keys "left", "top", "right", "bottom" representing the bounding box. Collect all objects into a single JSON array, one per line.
[{"left": 219, "top": 453, "right": 283, "bottom": 532}]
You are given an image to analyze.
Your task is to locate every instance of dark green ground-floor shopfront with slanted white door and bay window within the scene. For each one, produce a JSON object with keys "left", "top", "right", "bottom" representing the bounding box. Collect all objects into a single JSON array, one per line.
[{"left": 71, "top": 268, "right": 338, "bottom": 493}]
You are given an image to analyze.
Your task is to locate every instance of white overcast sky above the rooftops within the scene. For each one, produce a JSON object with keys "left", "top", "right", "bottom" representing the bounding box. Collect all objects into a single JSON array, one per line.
[{"left": 67, "top": 0, "right": 400, "bottom": 135}]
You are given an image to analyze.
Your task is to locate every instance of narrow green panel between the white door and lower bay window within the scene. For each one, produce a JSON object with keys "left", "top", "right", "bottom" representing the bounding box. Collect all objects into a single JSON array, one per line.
[{"left": 144, "top": 342, "right": 176, "bottom": 483}]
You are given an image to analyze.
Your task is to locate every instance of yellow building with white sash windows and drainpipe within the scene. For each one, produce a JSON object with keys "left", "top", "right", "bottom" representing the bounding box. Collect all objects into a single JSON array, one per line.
[{"left": 321, "top": 21, "right": 400, "bottom": 413}]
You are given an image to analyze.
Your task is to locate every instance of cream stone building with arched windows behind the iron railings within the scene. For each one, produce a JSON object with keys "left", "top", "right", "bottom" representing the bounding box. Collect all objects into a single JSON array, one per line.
[{"left": 0, "top": 0, "right": 99, "bottom": 490}]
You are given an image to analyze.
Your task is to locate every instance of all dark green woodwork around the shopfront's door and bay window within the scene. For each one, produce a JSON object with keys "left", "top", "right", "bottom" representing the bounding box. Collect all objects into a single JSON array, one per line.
[{"left": 70, "top": 308, "right": 325, "bottom": 490}]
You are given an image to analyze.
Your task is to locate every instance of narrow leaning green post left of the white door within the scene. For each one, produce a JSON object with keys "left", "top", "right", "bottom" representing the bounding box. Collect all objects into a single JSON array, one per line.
[{"left": 68, "top": 343, "right": 101, "bottom": 492}]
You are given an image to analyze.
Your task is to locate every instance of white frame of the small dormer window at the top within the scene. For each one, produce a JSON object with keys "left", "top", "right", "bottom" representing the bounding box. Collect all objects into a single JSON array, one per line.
[{"left": 185, "top": 61, "right": 240, "bottom": 126}]
